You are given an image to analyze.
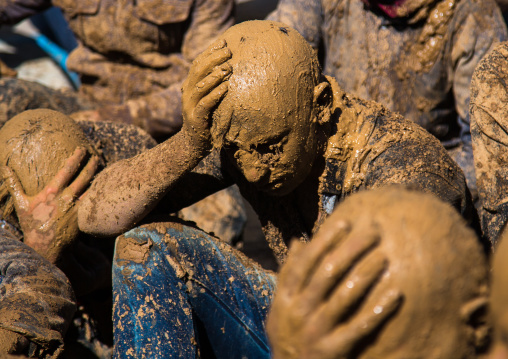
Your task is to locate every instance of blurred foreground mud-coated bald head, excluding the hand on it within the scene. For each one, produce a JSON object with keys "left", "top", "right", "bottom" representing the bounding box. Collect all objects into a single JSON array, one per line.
[{"left": 321, "top": 187, "right": 490, "bottom": 359}]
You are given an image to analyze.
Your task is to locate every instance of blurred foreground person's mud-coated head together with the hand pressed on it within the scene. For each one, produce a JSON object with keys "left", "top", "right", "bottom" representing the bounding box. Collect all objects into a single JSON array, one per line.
[{"left": 267, "top": 186, "right": 490, "bottom": 359}]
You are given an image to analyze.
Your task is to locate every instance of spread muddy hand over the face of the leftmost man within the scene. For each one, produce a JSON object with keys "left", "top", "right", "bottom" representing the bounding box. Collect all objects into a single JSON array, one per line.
[{"left": 0, "top": 148, "right": 99, "bottom": 263}]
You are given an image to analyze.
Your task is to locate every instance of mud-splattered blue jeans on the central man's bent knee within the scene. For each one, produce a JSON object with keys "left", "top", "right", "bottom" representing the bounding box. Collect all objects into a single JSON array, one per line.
[{"left": 113, "top": 223, "right": 276, "bottom": 358}]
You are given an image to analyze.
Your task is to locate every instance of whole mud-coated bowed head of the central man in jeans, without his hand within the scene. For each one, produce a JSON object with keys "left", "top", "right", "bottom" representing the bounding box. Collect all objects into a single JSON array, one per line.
[{"left": 212, "top": 21, "right": 326, "bottom": 195}]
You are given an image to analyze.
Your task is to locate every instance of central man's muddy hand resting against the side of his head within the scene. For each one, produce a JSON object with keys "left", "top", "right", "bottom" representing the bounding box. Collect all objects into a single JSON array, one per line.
[{"left": 182, "top": 40, "right": 232, "bottom": 150}]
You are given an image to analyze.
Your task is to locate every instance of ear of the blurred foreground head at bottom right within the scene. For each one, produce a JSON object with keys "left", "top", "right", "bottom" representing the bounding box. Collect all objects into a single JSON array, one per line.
[{"left": 460, "top": 296, "right": 492, "bottom": 352}]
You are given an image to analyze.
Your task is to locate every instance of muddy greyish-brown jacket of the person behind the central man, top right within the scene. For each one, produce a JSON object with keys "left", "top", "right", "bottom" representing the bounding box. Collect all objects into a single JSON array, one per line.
[{"left": 269, "top": 0, "right": 507, "bottom": 147}]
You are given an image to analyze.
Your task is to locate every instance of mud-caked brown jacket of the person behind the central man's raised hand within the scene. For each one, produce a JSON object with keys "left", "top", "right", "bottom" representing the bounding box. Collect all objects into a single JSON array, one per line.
[{"left": 0, "top": 0, "right": 234, "bottom": 139}]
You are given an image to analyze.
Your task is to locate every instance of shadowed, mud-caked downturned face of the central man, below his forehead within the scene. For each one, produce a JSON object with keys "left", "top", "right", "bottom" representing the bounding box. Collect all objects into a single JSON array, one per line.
[{"left": 220, "top": 92, "right": 317, "bottom": 196}]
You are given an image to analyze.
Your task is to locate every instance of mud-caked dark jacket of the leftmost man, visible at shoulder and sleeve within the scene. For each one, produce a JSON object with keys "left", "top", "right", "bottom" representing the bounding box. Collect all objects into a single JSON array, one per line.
[{"left": 0, "top": 122, "right": 156, "bottom": 358}]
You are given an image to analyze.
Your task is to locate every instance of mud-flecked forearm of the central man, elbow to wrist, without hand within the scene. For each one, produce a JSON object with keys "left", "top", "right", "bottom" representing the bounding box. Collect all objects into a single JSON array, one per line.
[{"left": 78, "top": 131, "right": 207, "bottom": 236}]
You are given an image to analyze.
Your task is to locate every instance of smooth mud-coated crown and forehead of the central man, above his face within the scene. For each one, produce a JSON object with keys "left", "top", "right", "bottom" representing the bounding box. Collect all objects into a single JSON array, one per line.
[{"left": 212, "top": 21, "right": 320, "bottom": 147}]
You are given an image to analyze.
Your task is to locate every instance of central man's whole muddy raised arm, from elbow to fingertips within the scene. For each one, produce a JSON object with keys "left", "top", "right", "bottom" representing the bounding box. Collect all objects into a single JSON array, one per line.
[{"left": 78, "top": 41, "right": 232, "bottom": 236}]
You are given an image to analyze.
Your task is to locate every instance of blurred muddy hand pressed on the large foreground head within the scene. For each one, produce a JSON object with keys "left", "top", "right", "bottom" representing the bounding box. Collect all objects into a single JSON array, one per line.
[{"left": 267, "top": 221, "right": 402, "bottom": 359}]
